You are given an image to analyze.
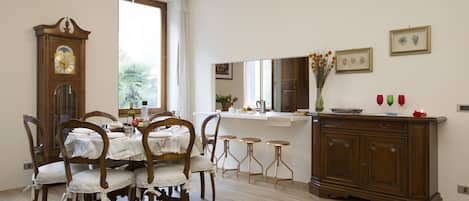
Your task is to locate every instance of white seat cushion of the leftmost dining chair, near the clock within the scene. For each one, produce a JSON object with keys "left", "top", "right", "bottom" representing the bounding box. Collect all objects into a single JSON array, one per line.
[{"left": 33, "top": 161, "right": 89, "bottom": 184}]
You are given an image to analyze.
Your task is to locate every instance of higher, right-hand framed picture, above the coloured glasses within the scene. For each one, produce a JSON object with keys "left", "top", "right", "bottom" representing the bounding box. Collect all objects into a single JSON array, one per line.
[{"left": 389, "top": 26, "right": 431, "bottom": 56}]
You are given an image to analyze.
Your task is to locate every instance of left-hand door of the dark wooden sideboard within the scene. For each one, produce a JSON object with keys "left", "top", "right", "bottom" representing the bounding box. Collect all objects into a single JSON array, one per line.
[{"left": 321, "top": 133, "right": 360, "bottom": 186}]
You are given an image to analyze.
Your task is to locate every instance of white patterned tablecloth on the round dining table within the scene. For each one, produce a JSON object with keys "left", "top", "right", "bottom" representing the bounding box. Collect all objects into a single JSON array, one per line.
[{"left": 65, "top": 126, "right": 203, "bottom": 161}]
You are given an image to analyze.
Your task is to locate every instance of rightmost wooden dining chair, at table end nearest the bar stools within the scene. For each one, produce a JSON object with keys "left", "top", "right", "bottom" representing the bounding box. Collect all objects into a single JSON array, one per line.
[{"left": 191, "top": 114, "right": 221, "bottom": 201}]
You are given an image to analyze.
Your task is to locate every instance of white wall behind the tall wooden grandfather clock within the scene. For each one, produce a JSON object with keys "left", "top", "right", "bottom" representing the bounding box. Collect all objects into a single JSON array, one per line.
[{"left": 0, "top": 0, "right": 118, "bottom": 190}]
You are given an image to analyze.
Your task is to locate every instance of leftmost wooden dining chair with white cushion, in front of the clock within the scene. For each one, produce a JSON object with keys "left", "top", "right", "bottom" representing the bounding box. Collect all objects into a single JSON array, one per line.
[{"left": 23, "top": 115, "right": 88, "bottom": 201}]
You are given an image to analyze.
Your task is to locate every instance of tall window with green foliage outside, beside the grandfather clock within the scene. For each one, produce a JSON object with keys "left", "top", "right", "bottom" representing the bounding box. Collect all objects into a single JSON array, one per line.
[{"left": 119, "top": 0, "right": 166, "bottom": 116}]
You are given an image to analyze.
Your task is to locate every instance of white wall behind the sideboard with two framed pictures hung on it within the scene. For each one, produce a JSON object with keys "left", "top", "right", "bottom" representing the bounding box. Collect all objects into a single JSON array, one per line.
[{"left": 190, "top": 0, "right": 469, "bottom": 201}]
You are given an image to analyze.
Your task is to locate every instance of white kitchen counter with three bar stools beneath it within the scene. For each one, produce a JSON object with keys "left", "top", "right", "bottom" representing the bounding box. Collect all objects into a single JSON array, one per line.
[{"left": 194, "top": 112, "right": 314, "bottom": 183}]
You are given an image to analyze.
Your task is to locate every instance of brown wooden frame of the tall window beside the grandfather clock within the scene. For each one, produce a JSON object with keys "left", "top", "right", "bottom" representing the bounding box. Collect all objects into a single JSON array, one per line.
[{"left": 119, "top": 0, "right": 168, "bottom": 117}]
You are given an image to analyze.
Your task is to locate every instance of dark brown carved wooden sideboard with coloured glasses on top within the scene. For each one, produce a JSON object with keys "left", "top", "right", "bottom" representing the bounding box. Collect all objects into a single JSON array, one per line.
[{"left": 310, "top": 113, "right": 446, "bottom": 201}]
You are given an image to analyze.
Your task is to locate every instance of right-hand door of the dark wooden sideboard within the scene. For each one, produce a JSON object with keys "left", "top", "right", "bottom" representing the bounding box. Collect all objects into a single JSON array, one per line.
[{"left": 361, "top": 136, "right": 407, "bottom": 196}]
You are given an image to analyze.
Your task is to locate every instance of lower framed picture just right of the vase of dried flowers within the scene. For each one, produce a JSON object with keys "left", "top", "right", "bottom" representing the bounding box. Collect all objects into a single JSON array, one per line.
[{"left": 335, "top": 47, "right": 373, "bottom": 73}]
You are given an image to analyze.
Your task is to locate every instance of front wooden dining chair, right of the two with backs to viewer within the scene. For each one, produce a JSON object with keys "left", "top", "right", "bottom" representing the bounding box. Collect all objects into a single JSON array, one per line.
[{"left": 135, "top": 118, "right": 195, "bottom": 201}]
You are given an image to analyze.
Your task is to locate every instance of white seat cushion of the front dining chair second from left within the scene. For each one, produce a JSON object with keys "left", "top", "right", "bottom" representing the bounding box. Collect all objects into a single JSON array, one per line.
[{"left": 68, "top": 168, "right": 135, "bottom": 193}]
